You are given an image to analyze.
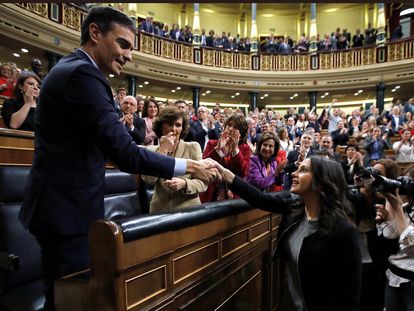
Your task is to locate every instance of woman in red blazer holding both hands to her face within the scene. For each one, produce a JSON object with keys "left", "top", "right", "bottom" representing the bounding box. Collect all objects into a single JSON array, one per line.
[{"left": 200, "top": 114, "right": 251, "bottom": 203}]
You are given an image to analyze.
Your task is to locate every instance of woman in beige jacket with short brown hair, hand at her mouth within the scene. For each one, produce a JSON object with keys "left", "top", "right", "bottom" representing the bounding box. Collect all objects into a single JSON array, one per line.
[{"left": 142, "top": 106, "right": 207, "bottom": 213}]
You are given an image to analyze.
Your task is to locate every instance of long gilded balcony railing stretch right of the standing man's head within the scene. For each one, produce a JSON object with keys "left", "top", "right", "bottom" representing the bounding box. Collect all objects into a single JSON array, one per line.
[{"left": 137, "top": 32, "right": 414, "bottom": 71}]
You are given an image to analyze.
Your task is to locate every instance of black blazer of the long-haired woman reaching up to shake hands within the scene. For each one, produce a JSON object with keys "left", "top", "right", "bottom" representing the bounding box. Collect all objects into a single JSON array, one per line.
[{"left": 230, "top": 176, "right": 362, "bottom": 311}]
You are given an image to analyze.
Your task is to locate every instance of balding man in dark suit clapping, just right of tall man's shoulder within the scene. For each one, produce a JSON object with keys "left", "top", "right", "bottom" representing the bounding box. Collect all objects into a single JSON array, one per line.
[{"left": 119, "top": 96, "right": 145, "bottom": 145}]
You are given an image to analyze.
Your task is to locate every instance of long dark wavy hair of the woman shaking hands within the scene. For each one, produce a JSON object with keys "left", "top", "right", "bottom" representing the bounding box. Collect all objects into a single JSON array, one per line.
[{"left": 310, "top": 156, "right": 352, "bottom": 233}]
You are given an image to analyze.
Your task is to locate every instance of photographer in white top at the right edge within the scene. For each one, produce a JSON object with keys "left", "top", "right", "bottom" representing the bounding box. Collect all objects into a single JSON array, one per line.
[{"left": 376, "top": 165, "right": 414, "bottom": 311}]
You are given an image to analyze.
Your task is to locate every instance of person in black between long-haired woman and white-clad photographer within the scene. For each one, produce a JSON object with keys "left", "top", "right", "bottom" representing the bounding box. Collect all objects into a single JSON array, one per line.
[{"left": 349, "top": 159, "right": 399, "bottom": 311}]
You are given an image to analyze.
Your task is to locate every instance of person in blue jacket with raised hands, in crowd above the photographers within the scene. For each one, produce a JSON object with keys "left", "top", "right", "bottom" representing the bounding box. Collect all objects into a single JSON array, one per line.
[{"left": 364, "top": 127, "right": 391, "bottom": 166}]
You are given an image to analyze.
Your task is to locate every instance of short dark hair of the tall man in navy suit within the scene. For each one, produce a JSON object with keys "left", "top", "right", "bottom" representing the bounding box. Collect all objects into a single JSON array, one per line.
[{"left": 81, "top": 6, "right": 136, "bottom": 44}]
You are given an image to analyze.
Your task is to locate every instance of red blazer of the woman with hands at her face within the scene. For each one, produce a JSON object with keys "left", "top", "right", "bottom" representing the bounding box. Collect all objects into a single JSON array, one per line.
[{"left": 200, "top": 140, "right": 252, "bottom": 203}]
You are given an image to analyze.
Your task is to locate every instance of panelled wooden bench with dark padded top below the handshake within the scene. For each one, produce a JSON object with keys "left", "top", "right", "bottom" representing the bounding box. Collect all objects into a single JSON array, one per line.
[{"left": 55, "top": 200, "right": 281, "bottom": 311}]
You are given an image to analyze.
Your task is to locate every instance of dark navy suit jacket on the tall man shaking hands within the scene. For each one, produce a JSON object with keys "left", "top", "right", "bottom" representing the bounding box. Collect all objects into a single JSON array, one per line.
[{"left": 20, "top": 50, "right": 175, "bottom": 235}]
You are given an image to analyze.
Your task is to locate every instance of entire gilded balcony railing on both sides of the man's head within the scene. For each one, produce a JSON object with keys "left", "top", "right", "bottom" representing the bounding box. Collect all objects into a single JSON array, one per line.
[{"left": 16, "top": 3, "right": 414, "bottom": 72}]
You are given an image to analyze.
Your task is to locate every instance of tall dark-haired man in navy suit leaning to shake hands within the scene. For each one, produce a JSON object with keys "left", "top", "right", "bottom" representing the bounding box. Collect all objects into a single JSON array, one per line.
[{"left": 19, "top": 7, "right": 218, "bottom": 311}]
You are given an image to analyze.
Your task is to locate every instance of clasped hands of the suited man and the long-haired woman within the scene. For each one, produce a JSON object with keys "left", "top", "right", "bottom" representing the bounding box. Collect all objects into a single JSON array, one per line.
[{"left": 187, "top": 159, "right": 235, "bottom": 184}]
